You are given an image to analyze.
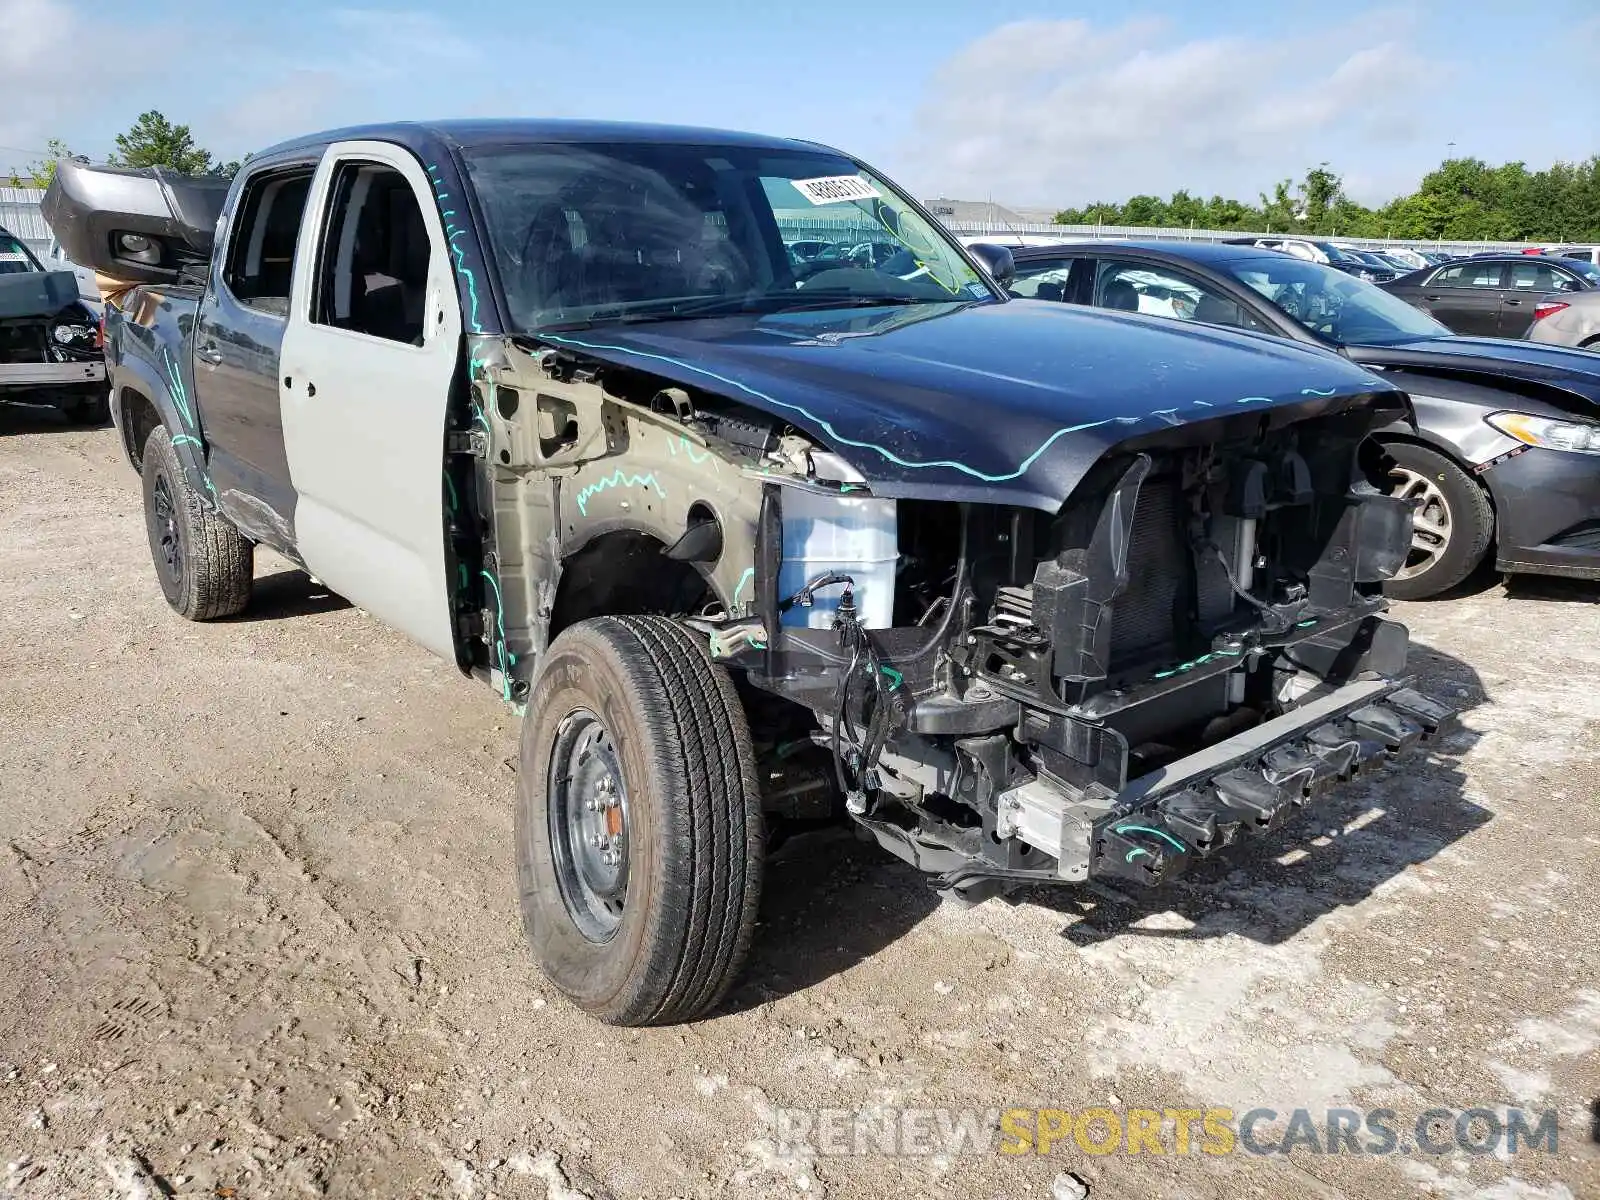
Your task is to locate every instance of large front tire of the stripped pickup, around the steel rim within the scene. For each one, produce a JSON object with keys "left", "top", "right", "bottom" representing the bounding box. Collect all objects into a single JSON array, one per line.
[{"left": 517, "top": 616, "right": 765, "bottom": 1026}]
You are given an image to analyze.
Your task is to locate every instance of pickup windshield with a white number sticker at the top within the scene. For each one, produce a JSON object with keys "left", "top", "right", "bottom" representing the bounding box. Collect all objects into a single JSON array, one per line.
[{"left": 467, "top": 142, "right": 998, "bottom": 333}]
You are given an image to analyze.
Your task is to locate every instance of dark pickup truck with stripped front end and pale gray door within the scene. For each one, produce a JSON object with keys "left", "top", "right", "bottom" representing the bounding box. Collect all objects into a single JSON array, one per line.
[{"left": 46, "top": 122, "right": 1450, "bottom": 1024}]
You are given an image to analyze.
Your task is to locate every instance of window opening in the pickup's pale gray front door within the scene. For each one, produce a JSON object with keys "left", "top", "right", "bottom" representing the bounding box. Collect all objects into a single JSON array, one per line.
[{"left": 310, "top": 163, "right": 432, "bottom": 346}]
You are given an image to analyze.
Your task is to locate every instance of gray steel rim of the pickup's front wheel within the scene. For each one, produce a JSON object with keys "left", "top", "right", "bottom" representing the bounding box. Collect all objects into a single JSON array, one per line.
[{"left": 549, "top": 709, "right": 630, "bottom": 944}]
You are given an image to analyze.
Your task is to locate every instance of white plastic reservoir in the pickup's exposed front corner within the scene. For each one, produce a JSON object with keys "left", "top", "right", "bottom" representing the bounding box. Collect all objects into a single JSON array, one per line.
[{"left": 778, "top": 488, "right": 899, "bottom": 629}]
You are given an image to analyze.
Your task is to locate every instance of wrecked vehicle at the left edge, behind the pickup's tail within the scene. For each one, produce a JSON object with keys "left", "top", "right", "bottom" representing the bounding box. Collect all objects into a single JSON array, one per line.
[{"left": 0, "top": 229, "right": 106, "bottom": 424}]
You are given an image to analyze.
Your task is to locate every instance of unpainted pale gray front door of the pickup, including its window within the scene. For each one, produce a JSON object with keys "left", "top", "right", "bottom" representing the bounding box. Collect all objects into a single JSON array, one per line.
[{"left": 278, "top": 141, "right": 461, "bottom": 658}]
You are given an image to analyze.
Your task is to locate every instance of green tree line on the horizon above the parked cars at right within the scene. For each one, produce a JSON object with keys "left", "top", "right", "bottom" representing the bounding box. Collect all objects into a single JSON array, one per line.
[{"left": 1056, "top": 155, "right": 1600, "bottom": 242}]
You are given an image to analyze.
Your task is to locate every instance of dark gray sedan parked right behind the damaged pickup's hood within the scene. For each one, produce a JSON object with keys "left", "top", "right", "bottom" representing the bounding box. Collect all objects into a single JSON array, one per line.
[{"left": 1008, "top": 242, "right": 1600, "bottom": 598}]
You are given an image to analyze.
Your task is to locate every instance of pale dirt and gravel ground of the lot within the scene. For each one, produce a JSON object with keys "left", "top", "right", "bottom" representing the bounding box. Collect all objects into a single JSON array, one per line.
[{"left": 0, "top": 408, "right": 1600, "bottom": 1200}]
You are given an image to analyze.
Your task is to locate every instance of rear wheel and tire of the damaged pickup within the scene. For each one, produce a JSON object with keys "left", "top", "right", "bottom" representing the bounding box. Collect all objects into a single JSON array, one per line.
[{"left": 141, "top": 426, "right": 254, "bottom": 621}]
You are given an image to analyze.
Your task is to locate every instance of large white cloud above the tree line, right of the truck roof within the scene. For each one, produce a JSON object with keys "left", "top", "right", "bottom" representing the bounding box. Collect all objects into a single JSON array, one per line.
[{"left": 906, "top": 14, "right": 1443, "bottom": 205}]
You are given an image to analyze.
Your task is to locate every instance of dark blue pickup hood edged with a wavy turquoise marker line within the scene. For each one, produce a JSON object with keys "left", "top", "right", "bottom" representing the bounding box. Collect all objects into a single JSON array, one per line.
[{"left": 538, "top": 301, "right": 1400, "bottom": 510}]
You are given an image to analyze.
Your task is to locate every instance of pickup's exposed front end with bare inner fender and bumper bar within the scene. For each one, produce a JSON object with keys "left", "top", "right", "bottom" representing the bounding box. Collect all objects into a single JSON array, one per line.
[{"left": 454, "top": 341, "right": 1450, "bottom": 898}]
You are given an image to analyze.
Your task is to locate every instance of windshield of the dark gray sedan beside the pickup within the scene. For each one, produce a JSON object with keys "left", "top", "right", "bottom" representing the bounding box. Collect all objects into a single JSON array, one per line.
[{"left": 1222, "top": 258, "right": 1450, "bottom": 346}]
